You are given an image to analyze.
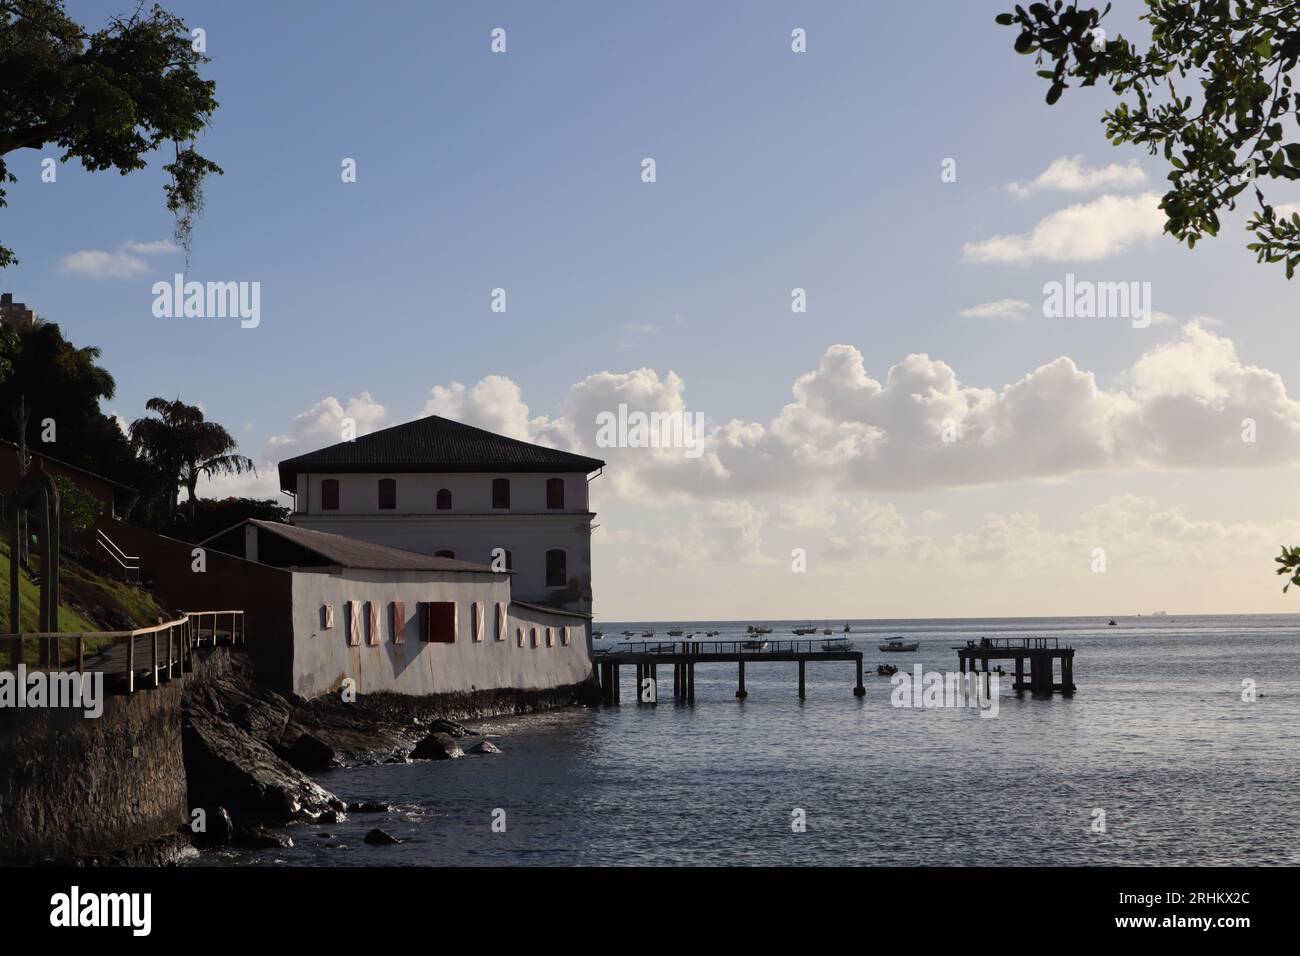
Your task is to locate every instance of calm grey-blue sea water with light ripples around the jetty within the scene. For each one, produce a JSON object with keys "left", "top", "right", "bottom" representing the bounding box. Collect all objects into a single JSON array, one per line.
[{"left": 202, "top": 615, "right": 1300, "bottom": 865}]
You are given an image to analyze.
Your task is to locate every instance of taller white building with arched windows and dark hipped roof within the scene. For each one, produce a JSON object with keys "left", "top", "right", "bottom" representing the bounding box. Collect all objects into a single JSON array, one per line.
[{"left": 280, "top": 415, "right": 605, "bottom": 614}]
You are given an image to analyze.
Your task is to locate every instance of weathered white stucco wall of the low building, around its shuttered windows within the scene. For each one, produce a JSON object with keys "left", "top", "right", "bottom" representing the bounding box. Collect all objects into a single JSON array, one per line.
[{"left": 293, "top": 570, "right": 592, "bottom": 697}]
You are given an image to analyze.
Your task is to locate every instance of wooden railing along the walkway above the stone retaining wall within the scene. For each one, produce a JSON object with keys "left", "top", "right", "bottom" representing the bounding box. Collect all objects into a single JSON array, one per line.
[{"left": 0, "top": 610, "right": 247, "bottom": 693}]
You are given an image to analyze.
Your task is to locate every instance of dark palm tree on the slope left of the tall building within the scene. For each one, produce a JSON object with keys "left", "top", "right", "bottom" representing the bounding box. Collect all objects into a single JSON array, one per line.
[{"left": 131, "top": 398, "right": 257, "bottom": 535}]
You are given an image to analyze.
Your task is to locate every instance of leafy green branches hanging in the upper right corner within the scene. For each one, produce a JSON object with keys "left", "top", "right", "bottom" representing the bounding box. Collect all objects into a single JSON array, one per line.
[{"left": 997, "top": 0, "right": 1300, "bottom": 278}]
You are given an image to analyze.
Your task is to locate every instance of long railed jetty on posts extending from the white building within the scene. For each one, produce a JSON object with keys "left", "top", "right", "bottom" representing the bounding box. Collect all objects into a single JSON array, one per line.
[{"left": 594, "top": 637, "right": 867, "bottom": 704}]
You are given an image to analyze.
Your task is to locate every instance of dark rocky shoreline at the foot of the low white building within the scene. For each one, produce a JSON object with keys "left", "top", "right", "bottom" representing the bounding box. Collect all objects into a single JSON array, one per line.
[{"left": 178, "top": 653, "right": 597, "bottom": 862}]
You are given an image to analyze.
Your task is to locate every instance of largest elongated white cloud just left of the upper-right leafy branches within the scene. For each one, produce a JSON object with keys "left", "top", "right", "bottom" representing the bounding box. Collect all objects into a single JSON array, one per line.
[{"left": 962, "top": 193, "right": 1165, "bottom": 263}]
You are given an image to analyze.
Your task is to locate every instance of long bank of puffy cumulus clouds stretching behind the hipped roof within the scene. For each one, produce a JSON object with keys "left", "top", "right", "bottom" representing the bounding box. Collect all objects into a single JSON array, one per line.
[{"left": 228, "top": 321, "right": 1300, "bottom": 509}]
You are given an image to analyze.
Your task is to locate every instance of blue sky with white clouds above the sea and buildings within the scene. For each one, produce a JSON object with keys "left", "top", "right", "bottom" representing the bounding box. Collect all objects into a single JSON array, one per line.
[{"left": 0, "top": 0, "right": 1300, "bottom": 620}]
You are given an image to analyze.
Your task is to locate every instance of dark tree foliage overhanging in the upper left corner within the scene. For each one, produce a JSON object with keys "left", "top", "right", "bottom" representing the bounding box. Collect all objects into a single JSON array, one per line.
[{"left": 0, "top": 0, "right": 221, "bottom": 268}]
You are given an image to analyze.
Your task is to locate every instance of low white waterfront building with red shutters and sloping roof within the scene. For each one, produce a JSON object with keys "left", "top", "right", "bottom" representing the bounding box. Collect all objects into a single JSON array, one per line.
[{"left": 204, "top": 520, "right": 592, "bottom": 706}]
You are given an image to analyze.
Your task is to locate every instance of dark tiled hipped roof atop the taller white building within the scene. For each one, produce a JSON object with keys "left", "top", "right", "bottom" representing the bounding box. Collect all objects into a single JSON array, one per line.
[{"left": 280, "top": 415, "right": 605, "bottom": 492}]
